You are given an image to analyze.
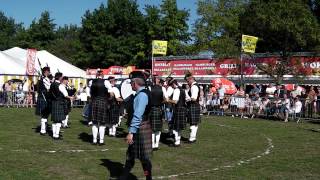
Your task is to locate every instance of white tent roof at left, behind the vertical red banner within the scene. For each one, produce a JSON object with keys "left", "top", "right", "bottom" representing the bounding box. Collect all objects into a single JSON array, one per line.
[{"left": 3, "top": 47, "right": 86, "bottom": 78}]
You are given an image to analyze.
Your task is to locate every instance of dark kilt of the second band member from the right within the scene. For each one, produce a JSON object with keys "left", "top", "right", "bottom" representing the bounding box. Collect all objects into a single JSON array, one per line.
[{"left": 172, "top": 106, "right": 187, "bottom": 131}]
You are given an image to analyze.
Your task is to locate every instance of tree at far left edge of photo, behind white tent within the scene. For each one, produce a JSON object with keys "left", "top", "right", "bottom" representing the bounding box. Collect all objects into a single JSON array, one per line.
[{"left": 0, "top": 12, "right": 22, "bottom": 50}]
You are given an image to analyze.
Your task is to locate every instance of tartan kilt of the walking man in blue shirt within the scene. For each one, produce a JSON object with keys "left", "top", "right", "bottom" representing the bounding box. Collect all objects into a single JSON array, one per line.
[{"left": 127, "top": 121, "right": 152, "bottom": 160}]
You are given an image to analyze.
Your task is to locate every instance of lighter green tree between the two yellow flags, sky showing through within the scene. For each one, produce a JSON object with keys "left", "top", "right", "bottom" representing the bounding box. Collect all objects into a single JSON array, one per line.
[{"left": 194, "top": 0, "right": 247, "bottom": 58}]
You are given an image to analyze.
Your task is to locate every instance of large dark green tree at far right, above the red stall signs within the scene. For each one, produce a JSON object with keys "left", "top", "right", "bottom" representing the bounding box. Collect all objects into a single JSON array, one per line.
[{"left": 240, "top": 0, "right": 320, "bottom": 83}]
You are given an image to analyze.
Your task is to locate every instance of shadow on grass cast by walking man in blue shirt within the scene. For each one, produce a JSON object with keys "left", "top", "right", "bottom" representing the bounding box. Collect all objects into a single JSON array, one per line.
[{"left": 100, "top": 159, "right": 138, "bottom": 180}]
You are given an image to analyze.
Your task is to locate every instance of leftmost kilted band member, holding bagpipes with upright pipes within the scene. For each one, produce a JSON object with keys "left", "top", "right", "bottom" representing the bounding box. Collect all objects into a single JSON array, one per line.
[{"left": 36, "top": 67, "right": 51, "bottom": 135}]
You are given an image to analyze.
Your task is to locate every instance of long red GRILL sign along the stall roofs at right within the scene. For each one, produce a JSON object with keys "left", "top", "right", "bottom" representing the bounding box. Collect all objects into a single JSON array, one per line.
[{"left": 153, "top": 57, "right": 320, "bottom": 76}]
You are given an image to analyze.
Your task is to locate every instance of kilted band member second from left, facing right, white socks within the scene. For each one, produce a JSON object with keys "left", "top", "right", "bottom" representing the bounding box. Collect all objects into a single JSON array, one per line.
[{"left": 50, "top": 72, "right": 73, "bottom": 140}]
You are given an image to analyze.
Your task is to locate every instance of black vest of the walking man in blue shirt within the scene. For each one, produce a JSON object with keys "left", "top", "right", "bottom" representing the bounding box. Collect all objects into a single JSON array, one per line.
[{"left": 127, "top": 89, "right": 151, "bottom": 126}]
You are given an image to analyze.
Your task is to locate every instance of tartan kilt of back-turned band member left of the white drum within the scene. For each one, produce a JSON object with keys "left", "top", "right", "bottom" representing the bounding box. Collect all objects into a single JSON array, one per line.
[{"left": 90, "top": 97, "right": 111, "bottom": 126}]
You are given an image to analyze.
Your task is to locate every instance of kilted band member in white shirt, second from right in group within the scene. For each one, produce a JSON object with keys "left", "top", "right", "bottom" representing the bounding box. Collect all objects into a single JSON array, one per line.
[{"left": 169, "top": 79, "right": 187, "bottom": 147}]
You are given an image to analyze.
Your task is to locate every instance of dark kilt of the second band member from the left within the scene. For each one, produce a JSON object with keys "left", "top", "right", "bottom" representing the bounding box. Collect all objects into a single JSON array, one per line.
[{"left": 51, "top": 100, "right": 66, "bottom": 123}]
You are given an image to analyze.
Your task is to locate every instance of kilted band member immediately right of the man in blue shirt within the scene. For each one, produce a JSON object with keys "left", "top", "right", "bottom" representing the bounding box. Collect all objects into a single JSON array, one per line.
[{"left": 149, "top": 75, "right": 164, "bottom": 150}]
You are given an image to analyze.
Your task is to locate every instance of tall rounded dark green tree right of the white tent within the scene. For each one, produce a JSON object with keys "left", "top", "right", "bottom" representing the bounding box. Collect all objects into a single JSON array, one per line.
[{"left": 80, "top": 0, "right": 145, "bottom": 67}]
